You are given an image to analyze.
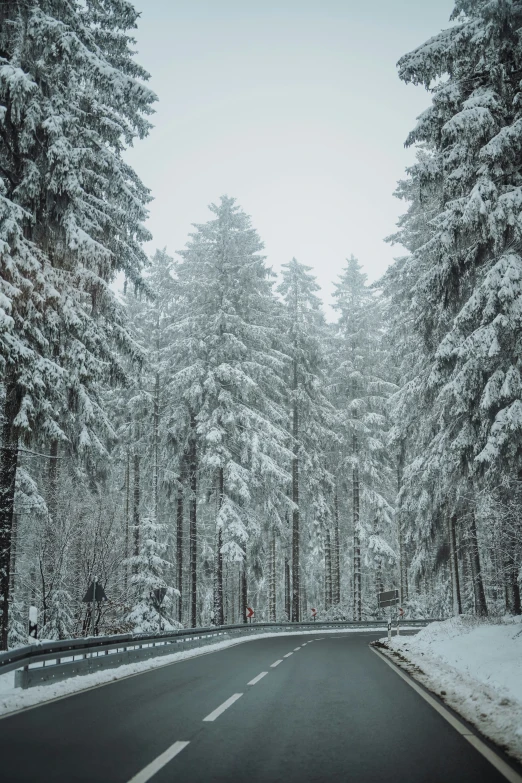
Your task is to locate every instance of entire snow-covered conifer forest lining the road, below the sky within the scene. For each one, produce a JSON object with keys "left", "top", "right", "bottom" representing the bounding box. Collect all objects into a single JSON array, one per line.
[{"left": 0, "top": 0, "right": 522, "bottom": 649}]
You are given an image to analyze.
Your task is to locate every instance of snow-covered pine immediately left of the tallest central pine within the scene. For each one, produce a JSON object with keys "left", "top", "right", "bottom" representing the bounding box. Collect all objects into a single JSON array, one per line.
[{"left": 105, "top": 250, "right": 183, "bottom": 620}]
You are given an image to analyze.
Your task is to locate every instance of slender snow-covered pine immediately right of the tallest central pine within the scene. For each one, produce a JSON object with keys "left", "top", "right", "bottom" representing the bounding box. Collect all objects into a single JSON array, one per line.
[{"left": 278, "top": 258, "right": 335, "bottom": 622}]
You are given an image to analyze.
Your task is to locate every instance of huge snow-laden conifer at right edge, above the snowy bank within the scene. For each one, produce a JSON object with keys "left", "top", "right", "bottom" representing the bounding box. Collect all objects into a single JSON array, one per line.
[{"left": 392, "top": 0, "right": 522, "bottom": 614}]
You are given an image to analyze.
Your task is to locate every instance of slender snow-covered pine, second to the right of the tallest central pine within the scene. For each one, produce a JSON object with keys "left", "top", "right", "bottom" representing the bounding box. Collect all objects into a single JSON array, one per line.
[{"left": 332, "top": 256, "right": 396, "bottom": 620}]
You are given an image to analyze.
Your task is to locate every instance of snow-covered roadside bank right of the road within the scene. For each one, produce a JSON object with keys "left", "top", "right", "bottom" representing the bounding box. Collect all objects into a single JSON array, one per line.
[{"left": 378, "top": 616, "right": 522, "bottom": 761}]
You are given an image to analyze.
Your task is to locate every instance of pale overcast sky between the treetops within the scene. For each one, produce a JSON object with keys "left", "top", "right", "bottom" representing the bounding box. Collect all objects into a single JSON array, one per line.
[{"left": 124, "top": 0, "right": 453, "bottom": 316}]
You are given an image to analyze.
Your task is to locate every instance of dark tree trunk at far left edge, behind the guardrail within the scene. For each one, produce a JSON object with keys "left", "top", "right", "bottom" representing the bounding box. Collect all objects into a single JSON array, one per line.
[{"left": 0, "top": 378, "right": 22, "bottom": 650}]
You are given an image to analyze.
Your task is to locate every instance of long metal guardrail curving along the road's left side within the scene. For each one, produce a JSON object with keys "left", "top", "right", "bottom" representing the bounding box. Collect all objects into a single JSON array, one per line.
[{"left": 0, "top": 619, "right": 434, "bottom": 688}]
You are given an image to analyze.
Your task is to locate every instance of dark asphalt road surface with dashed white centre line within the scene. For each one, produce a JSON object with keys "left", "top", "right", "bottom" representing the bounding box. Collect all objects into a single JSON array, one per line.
[{"left": 0, "top": 633, "right": 505, "bottom": 783}]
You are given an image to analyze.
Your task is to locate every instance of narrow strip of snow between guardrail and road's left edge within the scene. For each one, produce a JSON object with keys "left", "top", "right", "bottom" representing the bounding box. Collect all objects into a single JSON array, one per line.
[{"left": 0, "top": 628, "right": 414, "bottom": 715}]
